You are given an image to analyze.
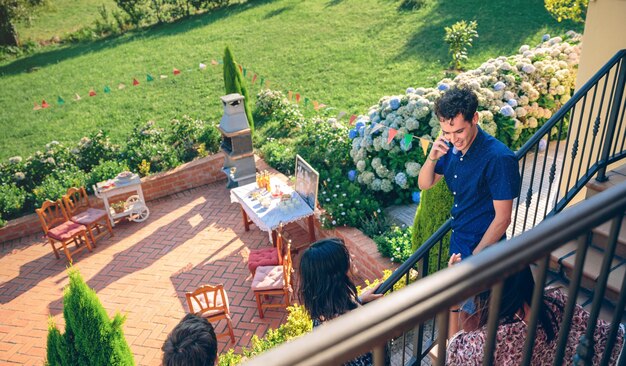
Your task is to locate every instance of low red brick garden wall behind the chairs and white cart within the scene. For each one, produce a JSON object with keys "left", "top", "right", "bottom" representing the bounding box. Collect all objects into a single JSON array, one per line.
[{"left": 0, "top": 153, "right": 226, "bottom": 243}]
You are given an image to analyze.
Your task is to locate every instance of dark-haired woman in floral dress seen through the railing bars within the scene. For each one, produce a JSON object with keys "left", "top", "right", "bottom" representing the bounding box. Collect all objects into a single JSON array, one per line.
[{"left": 446, "top": 267, "right": 624, "bottom": 365}]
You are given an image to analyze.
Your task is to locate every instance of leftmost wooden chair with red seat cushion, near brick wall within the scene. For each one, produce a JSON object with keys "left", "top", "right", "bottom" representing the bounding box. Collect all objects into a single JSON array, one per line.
[{"left": 35, "top": 200, "right": 92, "bottom": 263}]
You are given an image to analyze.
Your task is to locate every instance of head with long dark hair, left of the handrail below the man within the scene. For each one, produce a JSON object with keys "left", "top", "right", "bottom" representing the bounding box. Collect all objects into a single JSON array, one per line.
[{"left": 299, "top": 238, "right": 357, "bottom": 320}]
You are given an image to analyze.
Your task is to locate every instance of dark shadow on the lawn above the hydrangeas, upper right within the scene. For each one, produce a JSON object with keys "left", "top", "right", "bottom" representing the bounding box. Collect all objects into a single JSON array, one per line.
[{"left": 396, "top": 0, "right": 583, "bottom": 62}]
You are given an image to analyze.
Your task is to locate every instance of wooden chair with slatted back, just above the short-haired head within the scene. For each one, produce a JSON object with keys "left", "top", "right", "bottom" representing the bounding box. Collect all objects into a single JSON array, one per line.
[{"left": 185, "top": 284, "right": 235, "bottom": 343}]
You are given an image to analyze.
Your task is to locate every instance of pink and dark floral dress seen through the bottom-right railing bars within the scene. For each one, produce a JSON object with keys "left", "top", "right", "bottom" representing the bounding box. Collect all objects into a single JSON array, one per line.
[{"left": 446, "top": 289, "right": 624, "bottom": 366}]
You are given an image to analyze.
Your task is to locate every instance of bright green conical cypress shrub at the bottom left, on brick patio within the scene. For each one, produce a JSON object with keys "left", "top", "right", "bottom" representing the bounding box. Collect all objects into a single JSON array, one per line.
[{"left": 47, "top": 268, "right": 135, "bottom": 366}]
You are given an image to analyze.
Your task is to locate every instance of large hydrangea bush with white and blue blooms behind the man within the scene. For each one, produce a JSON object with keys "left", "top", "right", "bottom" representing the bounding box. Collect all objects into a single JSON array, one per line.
[{"left": 348, "top": 31, "right": 581, "bottom": 201}]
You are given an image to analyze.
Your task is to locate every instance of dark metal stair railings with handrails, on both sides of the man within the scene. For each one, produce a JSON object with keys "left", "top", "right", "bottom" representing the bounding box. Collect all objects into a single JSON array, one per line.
[{"left": 241, "top": 50, "right": 626, "bottom": 365}]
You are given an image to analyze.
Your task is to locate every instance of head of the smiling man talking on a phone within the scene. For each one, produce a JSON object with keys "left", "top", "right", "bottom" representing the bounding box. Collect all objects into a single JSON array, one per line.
[{"left": 435, "top": 87, "right": 478, "bottom": 153}]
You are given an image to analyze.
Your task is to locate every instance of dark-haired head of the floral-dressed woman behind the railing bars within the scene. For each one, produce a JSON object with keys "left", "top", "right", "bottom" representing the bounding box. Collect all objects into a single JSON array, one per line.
[{"left": 475, "top": 266, "right": 557, "bottom": 341}]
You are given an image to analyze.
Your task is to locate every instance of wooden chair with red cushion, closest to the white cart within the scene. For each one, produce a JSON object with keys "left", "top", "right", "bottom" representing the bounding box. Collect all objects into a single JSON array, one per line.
[{"left": 63, "top": 187, "right": 113, "bottom": 247}]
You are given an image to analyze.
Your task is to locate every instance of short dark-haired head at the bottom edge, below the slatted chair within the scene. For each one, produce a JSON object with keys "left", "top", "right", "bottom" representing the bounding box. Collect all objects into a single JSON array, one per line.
[{"left": 162, "top": 314, "right": 217, "bottom": 366}]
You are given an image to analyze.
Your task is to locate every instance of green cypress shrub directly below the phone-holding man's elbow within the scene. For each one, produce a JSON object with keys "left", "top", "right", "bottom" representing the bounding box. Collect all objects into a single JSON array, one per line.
[{"left": 412, "top": 178, "right": 453, "bottom": 274}]
